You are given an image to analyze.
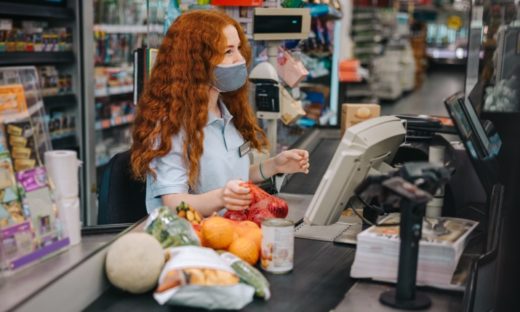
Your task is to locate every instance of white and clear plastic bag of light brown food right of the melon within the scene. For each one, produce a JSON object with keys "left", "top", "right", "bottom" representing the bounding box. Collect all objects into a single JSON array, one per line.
[{"left": 153, "top": 246, "right": 255, "bottom": 310}]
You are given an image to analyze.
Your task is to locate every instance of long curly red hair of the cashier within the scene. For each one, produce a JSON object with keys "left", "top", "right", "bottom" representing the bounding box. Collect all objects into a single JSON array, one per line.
[{"left": 131, "top": 10, "right": 268, "bottom": 188}]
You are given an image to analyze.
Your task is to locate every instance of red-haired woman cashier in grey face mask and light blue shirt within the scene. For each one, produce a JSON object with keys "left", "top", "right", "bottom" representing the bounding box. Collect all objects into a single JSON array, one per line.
[{"left": 131, "top": 10, "right": 309, "bottom": 216}]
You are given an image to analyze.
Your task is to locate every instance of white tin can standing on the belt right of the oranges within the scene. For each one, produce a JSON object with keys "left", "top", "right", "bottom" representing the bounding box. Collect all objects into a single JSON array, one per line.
[{"left": 260, "top": 219, "right": 294, "bottom": 274}]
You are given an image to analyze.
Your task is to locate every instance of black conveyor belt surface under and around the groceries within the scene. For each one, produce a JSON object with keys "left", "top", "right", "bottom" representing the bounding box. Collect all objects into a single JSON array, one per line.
[{"left": 84, "top": 238, "right": 356, "bottom": 312}]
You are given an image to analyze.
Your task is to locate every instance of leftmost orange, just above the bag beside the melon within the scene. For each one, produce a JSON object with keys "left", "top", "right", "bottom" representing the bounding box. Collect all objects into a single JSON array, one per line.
[{"left": 201, "top": 216, "right": 235, "bottom": 249}]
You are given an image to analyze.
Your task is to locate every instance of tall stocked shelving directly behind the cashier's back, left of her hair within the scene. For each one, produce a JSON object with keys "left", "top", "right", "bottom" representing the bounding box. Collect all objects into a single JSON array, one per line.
[{"left": 82, "top": 0, "right": 148, "bottom": 225}]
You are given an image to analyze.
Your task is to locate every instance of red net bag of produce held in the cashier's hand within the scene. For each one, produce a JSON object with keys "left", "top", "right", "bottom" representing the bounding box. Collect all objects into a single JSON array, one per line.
[{"left": 224, "top": 182, "right": 289, "bottom": 226}]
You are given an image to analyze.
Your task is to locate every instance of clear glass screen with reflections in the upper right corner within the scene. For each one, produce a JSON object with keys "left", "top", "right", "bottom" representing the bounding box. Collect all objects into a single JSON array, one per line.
[{"left": 466, "top": 0, "right": 520, "bottom": 113}]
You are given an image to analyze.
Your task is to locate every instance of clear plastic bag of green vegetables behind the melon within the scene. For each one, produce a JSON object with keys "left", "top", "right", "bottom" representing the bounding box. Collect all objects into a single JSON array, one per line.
[{"left": 145, "top": 207, "right": 200, "bottom": 248}]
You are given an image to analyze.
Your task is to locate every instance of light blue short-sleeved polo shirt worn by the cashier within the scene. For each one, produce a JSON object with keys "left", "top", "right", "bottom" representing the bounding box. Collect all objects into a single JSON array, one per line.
[{"left": 146, "top": 101, "right": 249, "bottom": 213}]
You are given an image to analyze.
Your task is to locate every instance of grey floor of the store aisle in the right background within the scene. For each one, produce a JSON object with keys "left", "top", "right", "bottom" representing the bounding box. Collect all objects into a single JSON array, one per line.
[{"left": 381, "top": 65, "right": 466, "bottom": 116}]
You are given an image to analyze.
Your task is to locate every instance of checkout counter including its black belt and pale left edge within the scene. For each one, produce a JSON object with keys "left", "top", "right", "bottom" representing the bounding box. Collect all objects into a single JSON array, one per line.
[{"left": 0, "top": 125, "right": 484, "bottom": 311}]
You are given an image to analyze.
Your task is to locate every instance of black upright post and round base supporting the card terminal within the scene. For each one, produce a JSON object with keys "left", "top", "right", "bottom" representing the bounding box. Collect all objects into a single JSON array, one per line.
[{"left": 379, "top": 177, "right": 432, "bottom": 310}]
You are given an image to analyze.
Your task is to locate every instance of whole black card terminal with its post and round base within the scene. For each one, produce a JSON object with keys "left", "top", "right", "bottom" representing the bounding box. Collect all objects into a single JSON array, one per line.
[{"left": 356, "top": 163, "right": 451, "bottom": 310}]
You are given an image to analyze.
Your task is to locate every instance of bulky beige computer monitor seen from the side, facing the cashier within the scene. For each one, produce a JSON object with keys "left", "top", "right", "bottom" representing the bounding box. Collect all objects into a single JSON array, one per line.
[{"left": 304, "top": 116, "right": 406, "bottom": 225}]
